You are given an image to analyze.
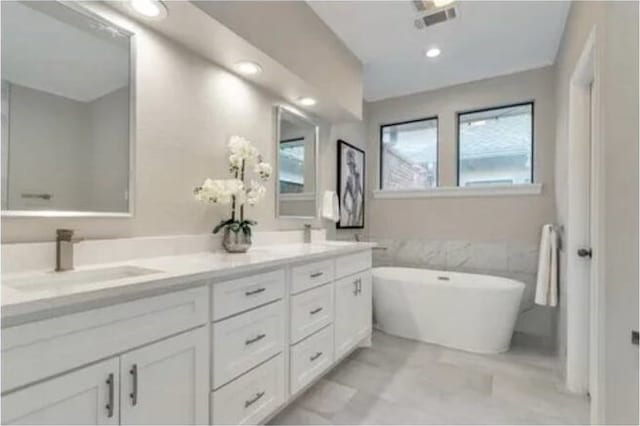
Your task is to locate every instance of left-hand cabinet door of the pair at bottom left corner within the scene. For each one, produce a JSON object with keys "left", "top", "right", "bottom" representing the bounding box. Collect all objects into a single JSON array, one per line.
[{"left": 2, "top": 358, "right": 119, "bottom": 425}]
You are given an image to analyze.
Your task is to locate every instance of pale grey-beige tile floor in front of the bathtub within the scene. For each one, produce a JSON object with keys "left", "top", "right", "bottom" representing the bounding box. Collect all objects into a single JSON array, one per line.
[{"left": 271, "top": 331, "right": 589, "bottom": 425}]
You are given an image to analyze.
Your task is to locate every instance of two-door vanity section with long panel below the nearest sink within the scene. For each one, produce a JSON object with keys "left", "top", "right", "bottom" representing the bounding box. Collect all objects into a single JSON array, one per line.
[{"left": 2, "top": 287, "right": 209, "bottom": 425}]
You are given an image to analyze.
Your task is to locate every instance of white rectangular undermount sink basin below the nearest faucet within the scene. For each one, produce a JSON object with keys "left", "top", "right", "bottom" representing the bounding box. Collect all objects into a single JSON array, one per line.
[{"left": 2, "top": 265, "right": 162, "bottom": 291}]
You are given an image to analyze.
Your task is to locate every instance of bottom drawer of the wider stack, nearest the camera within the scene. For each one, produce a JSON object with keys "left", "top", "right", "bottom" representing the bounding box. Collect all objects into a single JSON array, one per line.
[{"left": 211, "top": 354, "right": 285, "bottom": 425}]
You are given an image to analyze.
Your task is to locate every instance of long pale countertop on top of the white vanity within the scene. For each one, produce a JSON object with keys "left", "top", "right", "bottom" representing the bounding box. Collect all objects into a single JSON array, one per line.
[{"left": 2, "top": 241, "right": 376, "bottom": 328}]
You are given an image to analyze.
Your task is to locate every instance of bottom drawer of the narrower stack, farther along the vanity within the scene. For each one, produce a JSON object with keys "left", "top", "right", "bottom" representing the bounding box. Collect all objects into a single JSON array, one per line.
[{"left": 290, "top": 325, "right": 333, "bottom": 395}]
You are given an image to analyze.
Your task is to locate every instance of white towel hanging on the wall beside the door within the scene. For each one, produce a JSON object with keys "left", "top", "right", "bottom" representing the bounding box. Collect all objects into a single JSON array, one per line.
[{"left": 535, "top": 225, "right": 558, "bottom": 306}]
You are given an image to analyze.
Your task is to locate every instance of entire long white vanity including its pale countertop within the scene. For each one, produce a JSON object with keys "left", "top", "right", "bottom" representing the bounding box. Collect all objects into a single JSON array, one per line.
[{"left": 2, "top": 242, "right": 372, "bottom": 424}]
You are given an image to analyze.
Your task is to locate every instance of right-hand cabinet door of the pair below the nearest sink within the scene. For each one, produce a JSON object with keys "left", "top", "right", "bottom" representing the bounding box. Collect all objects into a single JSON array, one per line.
[{"left": 120, "top": 327, "right": 209, "bottom": 425}]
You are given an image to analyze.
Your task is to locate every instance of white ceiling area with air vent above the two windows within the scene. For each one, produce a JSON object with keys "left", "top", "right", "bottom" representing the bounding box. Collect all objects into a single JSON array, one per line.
[{"left": 308, "top": 0, "right": 570, "bottom": 101}]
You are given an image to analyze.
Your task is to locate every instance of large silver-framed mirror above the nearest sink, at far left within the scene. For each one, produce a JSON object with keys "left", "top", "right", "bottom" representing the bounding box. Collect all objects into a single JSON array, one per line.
[{"left": 0, "top": 1, "right": 135, "bottom": 217}]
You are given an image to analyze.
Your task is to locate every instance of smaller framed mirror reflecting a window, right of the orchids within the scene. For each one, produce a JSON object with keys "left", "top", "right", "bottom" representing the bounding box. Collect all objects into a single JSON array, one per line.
[{"left": 276, "top": 106, "right": 318, "bottom": 219}]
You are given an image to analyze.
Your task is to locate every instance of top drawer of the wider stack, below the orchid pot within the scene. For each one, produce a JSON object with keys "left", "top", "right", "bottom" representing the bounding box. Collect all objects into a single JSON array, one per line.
[{"left": 211, "top": 269, "right": 285, "bottom": 321}]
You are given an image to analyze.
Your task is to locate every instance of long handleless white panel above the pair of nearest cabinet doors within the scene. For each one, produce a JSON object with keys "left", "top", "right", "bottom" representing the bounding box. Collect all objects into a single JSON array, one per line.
[{"left": 2, "top": 283, "right": 209, "bottom": 392}]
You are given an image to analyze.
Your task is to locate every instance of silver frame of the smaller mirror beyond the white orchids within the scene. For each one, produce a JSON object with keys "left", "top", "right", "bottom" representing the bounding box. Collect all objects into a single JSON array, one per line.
[{"left": 275, "top": 105, "right": 320, "bottom": 220}]
